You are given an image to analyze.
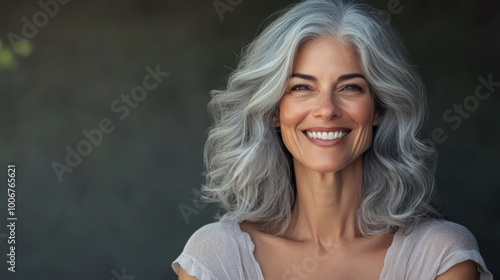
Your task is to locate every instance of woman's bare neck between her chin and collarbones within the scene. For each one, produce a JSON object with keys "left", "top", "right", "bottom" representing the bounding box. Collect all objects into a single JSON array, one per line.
[{"left": 286, "top": 157, "right": 363, "bottom": 245}]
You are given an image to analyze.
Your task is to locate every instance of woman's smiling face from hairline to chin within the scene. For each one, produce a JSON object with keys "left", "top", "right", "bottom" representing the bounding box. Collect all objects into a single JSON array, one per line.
[{"left": 275, "top": 37, "right": 378, "bottom": 173}]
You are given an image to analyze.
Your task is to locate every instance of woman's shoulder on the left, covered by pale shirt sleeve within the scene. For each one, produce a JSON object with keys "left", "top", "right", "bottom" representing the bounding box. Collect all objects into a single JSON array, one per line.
[{"left": 172, "top": 221, "right": 262, "bottom": 279}]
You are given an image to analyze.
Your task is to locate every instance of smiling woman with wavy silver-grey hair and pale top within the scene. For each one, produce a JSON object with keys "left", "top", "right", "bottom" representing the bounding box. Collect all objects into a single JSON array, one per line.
[{"left": 173, "top": 0, "right": 492, "bottom": 280}]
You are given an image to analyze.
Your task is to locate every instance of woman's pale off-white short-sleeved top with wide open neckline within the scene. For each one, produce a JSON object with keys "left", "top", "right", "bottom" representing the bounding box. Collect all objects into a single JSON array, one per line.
[{"left": 172, "top": 219, "right": 493, "bottom": 280}]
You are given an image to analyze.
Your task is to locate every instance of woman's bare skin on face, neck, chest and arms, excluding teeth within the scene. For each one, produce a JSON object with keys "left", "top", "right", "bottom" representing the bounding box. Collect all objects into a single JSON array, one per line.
[{"left": 179, "top": 37, "right": 478, "bottom": 280}]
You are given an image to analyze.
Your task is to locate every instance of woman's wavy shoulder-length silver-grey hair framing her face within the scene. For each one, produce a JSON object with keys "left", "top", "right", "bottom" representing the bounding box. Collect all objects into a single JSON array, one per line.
[{"left": 202, "top": 0, "right": 439, "bottom": 235}]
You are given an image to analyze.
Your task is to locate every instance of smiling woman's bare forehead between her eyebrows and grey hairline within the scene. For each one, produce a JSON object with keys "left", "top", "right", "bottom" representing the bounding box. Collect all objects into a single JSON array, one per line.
[{"left": 294, "top": 37, "right": 361, "bottom": 73}]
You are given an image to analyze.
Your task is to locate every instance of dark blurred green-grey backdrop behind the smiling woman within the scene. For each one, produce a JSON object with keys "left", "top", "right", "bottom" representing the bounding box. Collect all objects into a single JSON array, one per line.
[{"left": 0, "top": 0, "right": 500, "bottom": 280}]
